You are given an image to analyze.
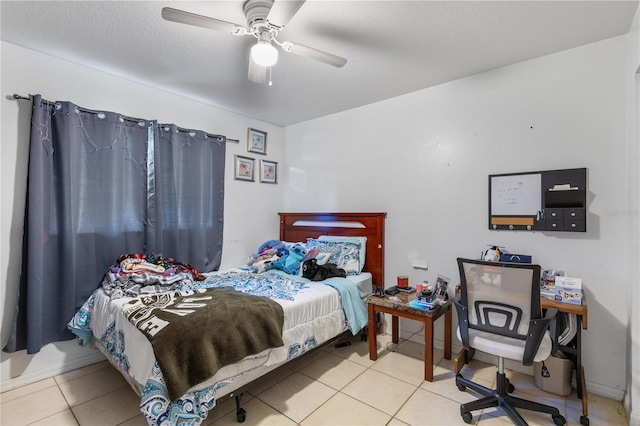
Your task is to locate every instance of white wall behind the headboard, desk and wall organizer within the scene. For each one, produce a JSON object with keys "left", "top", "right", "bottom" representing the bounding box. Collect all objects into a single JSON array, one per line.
[{"left": 284, "top": 36, "right": 638, "bottom": 400}]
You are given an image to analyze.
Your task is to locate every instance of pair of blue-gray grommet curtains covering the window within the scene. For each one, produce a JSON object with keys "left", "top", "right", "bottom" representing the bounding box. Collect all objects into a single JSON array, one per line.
[{"left": 4, "top": 95, "right": 226, "bottom": 353}]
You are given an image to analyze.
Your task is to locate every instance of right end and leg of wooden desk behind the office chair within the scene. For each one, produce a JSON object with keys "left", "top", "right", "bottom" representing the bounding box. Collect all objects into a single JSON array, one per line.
[{"left": 540, "top": 291, "right": 589, "bottom": 425}]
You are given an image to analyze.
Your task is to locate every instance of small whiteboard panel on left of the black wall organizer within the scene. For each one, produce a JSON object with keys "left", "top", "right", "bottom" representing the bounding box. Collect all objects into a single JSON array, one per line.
[{"left": 491, "top": 173, "right": 542, "bottom": 216}]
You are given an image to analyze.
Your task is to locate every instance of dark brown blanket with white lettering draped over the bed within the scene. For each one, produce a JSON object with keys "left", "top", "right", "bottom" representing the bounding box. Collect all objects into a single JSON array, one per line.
[{"left": 124, "top": 288, "right": 284, "bottom": 401}]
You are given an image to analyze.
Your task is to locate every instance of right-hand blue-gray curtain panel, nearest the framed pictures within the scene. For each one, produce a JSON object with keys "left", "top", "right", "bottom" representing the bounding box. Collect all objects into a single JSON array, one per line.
[{"left": 149, "top": 124, "right": 225, "bottom": 272}]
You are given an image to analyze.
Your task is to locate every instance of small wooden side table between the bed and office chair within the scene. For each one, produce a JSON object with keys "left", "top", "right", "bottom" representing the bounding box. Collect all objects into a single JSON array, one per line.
[{"left": 367, "top": 292, "right": 452, "bottom": 382}]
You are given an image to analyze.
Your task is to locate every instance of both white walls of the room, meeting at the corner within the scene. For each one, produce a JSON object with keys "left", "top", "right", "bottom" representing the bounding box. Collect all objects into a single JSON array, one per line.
[{"left": 0, "top": 30, "right": 640, "bottom": 416}]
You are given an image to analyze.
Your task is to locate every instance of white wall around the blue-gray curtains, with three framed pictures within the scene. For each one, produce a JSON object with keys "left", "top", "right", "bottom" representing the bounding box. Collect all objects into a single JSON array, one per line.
[{"left": 0, "top": 42, "right": 283, "bottom": 391}]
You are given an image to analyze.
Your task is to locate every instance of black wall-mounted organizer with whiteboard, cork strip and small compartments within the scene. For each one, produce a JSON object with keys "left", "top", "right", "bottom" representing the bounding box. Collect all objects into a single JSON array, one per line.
[{"left": 489, "top": 168, "right": 587, "bottom": 232}]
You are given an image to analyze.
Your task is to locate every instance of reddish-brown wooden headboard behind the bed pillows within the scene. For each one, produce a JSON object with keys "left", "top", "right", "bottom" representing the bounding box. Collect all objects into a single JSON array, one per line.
[{"left": 278, "top": 213, "right": 387, "bottom": 287}]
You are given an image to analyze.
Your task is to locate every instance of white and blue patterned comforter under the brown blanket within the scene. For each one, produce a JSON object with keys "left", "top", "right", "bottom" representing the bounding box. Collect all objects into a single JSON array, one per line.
[{"left": 68, "top": 270, "right": 366, "bottom": 425}]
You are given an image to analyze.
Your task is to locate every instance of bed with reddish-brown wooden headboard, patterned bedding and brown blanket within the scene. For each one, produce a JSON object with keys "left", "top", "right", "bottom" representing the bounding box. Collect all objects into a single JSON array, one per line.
[{"left": 69, "top": 213, "right": 386, "bottom": 425}]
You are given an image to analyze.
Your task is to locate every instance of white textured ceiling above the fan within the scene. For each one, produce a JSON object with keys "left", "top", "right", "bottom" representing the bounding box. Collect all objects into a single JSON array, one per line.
[{"left": 0, "top": 0, "right": 638, "bottom": 126}]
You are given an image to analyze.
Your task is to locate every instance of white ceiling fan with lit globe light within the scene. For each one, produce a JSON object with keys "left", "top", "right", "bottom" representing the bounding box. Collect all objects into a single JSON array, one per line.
[{"left": 162, "top": 0, "right": 347, "bottom": 83}]
